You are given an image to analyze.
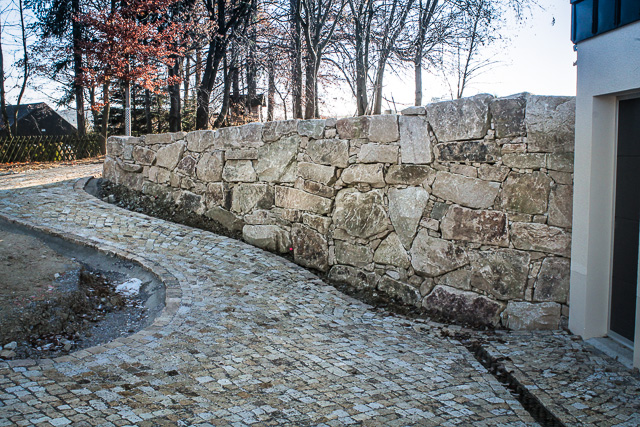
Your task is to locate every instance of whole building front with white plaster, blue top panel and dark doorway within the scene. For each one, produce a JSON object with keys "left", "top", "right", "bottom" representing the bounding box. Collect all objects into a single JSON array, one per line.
[{"left": 569, "top": 0, "right": 640, "bottom": 367}]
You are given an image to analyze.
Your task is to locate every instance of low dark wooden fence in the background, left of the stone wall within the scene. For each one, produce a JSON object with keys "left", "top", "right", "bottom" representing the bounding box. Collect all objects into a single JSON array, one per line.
[{"left": 0, "top": 134, "right": 102, "bottom": 163}]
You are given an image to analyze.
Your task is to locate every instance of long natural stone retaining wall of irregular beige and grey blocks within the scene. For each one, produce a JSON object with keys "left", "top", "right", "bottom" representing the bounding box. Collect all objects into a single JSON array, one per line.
[{"left": 104, "top": 94, "right": 575, "bottom": 329}]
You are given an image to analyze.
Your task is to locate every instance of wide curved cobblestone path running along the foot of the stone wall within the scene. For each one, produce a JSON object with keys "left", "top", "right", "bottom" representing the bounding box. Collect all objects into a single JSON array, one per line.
[{"left": 0, "top": 166, "right": 536, "bottom": 426}]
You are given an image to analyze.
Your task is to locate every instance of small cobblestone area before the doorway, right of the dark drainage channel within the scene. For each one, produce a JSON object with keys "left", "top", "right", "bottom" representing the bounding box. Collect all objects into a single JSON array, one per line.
[{"left": 483, "top": 332, "right": 640, "bottom": 426}]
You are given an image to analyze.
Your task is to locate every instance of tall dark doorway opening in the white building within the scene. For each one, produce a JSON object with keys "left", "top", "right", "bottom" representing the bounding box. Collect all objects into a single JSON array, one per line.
[{"left": 609, "top": 98, "right": 640, "bottom": 342}]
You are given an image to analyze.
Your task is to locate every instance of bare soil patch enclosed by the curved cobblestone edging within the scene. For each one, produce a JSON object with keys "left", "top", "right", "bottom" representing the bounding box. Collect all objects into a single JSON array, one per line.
[{"left": 0, "top": 220, "right": 164, "bottom": 359}]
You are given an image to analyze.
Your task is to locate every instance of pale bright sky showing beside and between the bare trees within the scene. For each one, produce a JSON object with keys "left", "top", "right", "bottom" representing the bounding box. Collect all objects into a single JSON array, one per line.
[{"left": 2, "top": 0, "right": 576, "bottom": 116}]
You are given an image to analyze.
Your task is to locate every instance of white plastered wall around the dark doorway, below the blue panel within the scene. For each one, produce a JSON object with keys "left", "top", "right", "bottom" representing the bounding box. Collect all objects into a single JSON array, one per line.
[{"left": 569, "top": 21, "right": 640, "bottom": 367}]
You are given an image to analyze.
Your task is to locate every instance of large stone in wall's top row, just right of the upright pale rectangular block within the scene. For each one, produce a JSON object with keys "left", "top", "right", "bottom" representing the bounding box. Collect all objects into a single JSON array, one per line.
[{"left": 425, "top": 94, "right": 493, "bottom": 142}]
